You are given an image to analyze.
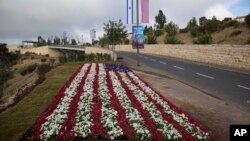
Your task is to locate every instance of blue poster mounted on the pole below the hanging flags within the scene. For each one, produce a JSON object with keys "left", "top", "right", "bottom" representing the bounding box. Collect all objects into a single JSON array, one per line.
[{"left": 132, "top": 25, "right": 144, "bottom": 49}]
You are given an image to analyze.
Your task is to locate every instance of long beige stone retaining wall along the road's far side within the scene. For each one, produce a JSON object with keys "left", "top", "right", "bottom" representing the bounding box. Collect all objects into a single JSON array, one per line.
[{"left": 116, "top": 45, "right": 250, "bottom": 70}]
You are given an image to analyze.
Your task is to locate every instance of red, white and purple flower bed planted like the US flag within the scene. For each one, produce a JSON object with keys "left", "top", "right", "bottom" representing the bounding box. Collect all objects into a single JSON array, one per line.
[{"left": 32, "top": 64, "right": 213, "bottom": 141}]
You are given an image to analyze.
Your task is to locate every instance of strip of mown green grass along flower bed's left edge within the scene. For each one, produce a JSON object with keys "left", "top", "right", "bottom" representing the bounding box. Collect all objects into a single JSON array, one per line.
[{"left": 0, "top": 63, "right": 81, "bottom": 141}]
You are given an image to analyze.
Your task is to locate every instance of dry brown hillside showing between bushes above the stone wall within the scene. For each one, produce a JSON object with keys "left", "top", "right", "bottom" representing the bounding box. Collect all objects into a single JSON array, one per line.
[{"left": 157, "top": 24, "right": 250, "bottom": 45}]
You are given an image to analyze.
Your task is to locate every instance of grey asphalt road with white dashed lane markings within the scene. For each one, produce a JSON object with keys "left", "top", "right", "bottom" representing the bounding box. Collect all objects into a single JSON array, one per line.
[{"left": 118, "top": 52, "right": 250, "bottom": 111}]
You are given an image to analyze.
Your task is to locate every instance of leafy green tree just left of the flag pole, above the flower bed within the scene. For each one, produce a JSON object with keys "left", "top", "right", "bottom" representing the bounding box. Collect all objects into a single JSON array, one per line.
[{"left": 103, "top": 20, "right": 128, "bottom": 45}]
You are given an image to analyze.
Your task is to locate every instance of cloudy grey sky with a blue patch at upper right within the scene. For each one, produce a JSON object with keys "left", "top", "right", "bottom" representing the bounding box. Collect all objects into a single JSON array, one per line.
[{"left": 0, "top": 0, "right": 250, "bottom": 43}]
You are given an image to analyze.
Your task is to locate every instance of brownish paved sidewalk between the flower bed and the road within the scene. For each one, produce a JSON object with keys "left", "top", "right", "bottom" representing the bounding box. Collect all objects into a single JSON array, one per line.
[{"left": 120, "top": 59, "right": 250, "bottom": 141}]
